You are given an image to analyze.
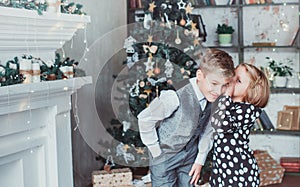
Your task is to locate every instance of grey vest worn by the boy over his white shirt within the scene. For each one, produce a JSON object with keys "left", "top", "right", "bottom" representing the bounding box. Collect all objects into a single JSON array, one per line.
[{"left": 152, "top": 83, "right": 210, "bottom": 164}]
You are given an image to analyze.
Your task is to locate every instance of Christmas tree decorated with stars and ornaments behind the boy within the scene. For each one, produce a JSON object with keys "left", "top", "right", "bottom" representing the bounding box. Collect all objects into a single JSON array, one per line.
[{"left": 99, "top": 0, "right": 211, "bottom": 178}]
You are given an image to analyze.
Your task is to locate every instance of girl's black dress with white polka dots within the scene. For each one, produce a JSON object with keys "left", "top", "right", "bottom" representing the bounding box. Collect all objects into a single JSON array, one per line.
[{"left": 210, "top": 96, "right": 261, "bottom": 187}]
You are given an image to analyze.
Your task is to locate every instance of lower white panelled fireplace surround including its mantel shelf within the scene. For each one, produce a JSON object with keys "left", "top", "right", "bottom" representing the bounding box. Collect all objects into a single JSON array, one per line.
[{"left": 0, "top": 77, "right": 92, "bottom": 187}]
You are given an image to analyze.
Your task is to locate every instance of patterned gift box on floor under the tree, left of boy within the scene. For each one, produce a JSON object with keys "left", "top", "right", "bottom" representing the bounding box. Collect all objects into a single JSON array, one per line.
[{"left": 92, "top": 168, "right": 133, "bottom": 187}]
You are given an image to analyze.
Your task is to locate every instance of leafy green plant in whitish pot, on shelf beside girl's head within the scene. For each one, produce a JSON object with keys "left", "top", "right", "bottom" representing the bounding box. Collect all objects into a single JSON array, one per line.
[{"left": 266, "top": 57, "right": 293, "bottom": 87}]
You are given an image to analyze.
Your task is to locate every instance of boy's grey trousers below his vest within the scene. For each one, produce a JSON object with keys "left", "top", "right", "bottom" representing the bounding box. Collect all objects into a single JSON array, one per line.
[{"left": 150, "top": 142, "right": 198, "bottom": 187}]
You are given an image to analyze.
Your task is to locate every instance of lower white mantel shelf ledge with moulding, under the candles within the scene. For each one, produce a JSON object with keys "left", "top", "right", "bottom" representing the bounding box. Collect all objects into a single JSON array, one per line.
[{"left": 0, "top": 76, "right": 92, "bottom": 115}]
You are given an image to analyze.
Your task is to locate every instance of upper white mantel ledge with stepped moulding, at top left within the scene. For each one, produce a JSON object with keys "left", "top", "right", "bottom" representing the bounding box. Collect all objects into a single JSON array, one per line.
[{"left": 0, "top": 7, "right": 91, "bottom": 52}]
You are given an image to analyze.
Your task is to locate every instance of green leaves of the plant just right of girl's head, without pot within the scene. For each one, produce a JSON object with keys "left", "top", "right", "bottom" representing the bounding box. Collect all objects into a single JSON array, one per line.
[{"left": 266, "top": 57, "right": 293, "bottom": 77}]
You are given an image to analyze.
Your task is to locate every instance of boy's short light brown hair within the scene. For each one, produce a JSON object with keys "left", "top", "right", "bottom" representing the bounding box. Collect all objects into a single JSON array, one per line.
[{"left": 199, "top": 48, "right": 235, "bottom": 78}]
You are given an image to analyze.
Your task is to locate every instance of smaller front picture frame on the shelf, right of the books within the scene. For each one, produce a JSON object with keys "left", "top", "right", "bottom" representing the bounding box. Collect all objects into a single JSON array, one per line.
[{"left": 277, "top": 110, "right": 293, "bottom": 130}]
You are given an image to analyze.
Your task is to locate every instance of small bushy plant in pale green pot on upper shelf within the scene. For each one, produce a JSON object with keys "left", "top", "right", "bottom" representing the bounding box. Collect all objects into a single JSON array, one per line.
[{"left": 216, "top": 23, "right": 234, "bottom": 46}]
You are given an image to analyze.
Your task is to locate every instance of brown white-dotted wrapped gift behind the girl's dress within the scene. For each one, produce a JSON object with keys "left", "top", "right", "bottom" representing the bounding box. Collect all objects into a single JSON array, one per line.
[{"left": 254, "top": 150, "right": 285, "bottom": 186}]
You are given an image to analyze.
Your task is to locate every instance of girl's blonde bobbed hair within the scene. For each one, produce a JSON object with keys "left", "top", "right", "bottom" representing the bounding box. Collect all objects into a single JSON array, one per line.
[{"left": 237, "top": 63, "right": 270, "bottom": 108}]
